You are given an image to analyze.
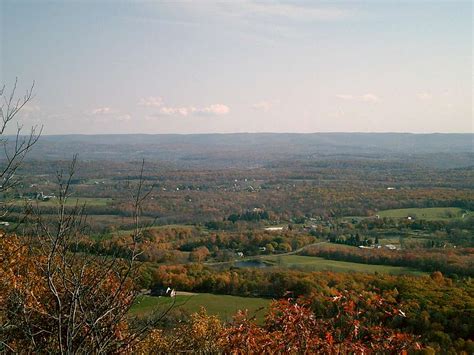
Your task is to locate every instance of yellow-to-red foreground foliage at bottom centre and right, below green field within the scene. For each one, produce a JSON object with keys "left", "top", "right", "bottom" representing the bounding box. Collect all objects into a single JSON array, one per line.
[{"left": 139, "top": 293, "right": 420, "bottom": 354}]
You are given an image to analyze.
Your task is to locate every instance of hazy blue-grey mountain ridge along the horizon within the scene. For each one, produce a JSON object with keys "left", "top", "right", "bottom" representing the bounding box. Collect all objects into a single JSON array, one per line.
[{"left": 12, "top": 133, "right": 474, "bottom": 167}]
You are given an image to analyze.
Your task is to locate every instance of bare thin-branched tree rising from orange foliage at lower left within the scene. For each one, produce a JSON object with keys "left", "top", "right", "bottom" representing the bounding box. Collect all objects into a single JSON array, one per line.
[{"left": 0, "top": 157, "right": 174, "bottom": 354}]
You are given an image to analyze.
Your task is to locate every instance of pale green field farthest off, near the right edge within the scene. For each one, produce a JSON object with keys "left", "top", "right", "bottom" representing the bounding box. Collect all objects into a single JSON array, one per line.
[{"left": 377, "top": 207, "right": 472, "bottom": 220}]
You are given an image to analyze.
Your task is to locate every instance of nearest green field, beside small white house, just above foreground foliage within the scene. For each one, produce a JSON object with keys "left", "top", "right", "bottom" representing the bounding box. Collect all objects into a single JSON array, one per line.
[{"left": 130, "top": 293, "right": 270, "bottom": 321}]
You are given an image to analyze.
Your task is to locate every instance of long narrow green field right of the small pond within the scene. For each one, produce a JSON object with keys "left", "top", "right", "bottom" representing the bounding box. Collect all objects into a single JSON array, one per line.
[{"left": 265, "top": 255, "right": 423, "bottom": 275}]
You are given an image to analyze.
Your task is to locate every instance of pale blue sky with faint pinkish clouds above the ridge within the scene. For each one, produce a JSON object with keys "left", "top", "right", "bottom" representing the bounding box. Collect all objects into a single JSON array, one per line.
[{"left": 0, "top": 0, "right": 473, "bottom": 134}]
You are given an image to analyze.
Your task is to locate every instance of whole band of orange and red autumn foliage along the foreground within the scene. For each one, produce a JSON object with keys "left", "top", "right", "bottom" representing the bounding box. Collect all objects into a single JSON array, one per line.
[{"left": 0, "top": 231, "right": 419, "bottom": 354}]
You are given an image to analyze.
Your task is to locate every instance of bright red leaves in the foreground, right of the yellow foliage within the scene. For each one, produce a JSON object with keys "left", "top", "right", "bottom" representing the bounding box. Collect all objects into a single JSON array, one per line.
[{"left": 218, "top": 292, "right": 418, "bottom": 353}]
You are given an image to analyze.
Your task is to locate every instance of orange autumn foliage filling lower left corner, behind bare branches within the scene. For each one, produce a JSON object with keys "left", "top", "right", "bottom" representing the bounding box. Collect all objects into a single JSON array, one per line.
[{"left": 0, "top": 235, "right": 133, "bottom": 352}]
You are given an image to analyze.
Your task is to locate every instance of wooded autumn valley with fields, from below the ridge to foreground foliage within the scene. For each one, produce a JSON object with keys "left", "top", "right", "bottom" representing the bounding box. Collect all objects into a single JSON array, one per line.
[{"left": 1, "top": 133, "right": 474, "bottom": 353}]
